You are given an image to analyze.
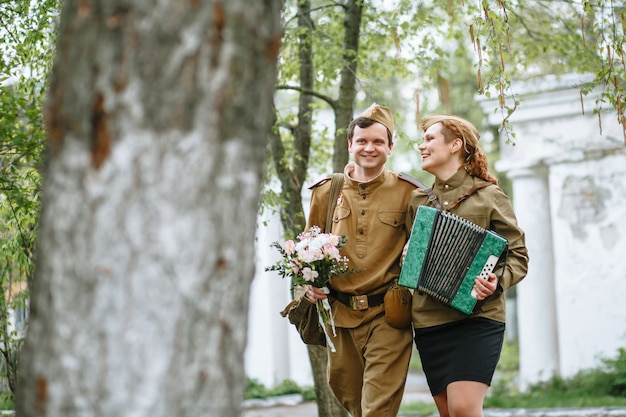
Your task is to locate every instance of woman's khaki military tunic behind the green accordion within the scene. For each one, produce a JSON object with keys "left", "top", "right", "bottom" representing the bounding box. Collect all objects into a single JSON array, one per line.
[{"left": 407, "top": 169, "right": 528, "bottom": 328}]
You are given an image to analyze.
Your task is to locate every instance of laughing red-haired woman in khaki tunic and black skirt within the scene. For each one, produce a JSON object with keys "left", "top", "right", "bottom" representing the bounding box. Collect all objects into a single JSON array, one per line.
[{"left": 405, "top": 115, "right": 528, "bottom": 417}]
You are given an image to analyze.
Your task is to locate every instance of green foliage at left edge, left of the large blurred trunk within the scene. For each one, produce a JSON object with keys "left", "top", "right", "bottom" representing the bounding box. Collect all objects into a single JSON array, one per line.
[{"left": 0, "top": 0, "right": 60, "bottom": 400}]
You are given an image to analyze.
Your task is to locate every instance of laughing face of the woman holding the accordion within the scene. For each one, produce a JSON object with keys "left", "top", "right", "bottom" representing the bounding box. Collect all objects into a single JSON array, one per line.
[{"left": 418, "top": 123, "right": 463, "bottom": 180}]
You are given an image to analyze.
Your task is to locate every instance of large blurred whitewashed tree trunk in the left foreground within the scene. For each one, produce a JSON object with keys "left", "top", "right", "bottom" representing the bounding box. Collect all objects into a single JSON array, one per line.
[{"left": 16, "top": 0, "right": 281, "bottom": 417}]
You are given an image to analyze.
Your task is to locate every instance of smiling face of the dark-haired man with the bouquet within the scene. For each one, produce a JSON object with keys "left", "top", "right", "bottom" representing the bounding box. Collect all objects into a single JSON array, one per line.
[{"left": 348, "top": 123, "right": 393, "bottom": 181}]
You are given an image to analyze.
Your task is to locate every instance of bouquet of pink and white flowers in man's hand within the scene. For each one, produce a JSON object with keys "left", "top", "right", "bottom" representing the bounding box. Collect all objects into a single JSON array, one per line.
[{"left": 265, "top": 226, "right": 349, "bottom": 352}]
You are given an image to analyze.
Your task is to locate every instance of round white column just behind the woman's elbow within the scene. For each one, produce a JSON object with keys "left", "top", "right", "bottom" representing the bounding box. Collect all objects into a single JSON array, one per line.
[{"left": 507, "top": 167, "right": 559, "bottom": 390}]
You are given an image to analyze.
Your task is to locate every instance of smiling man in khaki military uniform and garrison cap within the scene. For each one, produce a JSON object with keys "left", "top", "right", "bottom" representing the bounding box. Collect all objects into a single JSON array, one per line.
[{"left": 305, "top": 103, "right": 415, "bottom": 417}]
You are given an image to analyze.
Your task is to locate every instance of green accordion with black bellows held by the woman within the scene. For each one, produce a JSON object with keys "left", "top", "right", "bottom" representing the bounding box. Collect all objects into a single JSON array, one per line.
[{"left": 398, "top": 206, "right": 508, "bottom": 314}]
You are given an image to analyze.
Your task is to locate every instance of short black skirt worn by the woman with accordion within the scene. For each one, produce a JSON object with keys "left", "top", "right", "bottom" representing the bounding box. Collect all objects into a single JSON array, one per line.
[{"left": 415, "top": 317, "right": 505, "bottom": 395}]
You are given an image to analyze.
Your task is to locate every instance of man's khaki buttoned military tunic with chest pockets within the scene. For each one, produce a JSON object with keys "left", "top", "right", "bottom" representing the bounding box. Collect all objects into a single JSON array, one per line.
[{"left": 306, "top": 164, "right": 415, "bottom": 328}]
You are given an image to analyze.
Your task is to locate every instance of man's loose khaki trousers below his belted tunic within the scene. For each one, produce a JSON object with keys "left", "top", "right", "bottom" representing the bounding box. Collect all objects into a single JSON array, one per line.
[{"left": 327, "top": 314, "right": 413, "bottom": 417}]
